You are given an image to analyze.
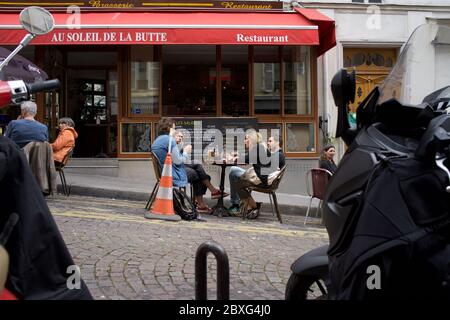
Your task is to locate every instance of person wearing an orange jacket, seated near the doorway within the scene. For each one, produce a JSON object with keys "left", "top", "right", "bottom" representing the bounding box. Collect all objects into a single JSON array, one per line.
[{"left": 52, "top": 118, "right": 78, "bottom": 163}]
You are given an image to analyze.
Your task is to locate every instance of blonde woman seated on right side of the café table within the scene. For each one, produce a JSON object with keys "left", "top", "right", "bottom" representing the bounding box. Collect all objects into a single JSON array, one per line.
[{"left": 228, "top": 130, "right": 278, "bottom": 216}]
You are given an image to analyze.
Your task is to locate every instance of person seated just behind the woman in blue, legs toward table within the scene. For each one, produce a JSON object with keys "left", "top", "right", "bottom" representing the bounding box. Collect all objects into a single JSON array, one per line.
[{"left": 175, "top": 130, "right": 229, "bottom": 213}]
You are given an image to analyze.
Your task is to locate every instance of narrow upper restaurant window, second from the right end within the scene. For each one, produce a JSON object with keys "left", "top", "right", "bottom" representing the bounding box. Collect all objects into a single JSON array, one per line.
[{"left": 253, "top": 46, "right": 280, "bottom": 114}]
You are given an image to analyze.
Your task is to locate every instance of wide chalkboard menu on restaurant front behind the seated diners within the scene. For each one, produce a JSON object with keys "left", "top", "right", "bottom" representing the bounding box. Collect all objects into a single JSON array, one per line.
[{"left": 172, "top": 117, "right": 258, "bottom": 161}]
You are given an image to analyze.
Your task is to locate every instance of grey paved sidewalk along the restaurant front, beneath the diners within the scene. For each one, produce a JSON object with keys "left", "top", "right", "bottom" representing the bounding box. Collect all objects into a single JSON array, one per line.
[{"left": 58, "top": 173, "right": 319, "bottom": 215}]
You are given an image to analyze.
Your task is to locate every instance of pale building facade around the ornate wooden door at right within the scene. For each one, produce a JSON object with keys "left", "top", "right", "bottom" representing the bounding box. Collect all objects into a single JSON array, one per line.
[{"left": 300, "top": 0, "right": 450, "bottom": 158}]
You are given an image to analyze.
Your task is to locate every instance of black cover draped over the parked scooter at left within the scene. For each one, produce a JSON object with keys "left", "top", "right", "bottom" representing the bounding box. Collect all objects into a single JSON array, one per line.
[{"left": 0, "top": 137, "right": 92, "bottom": 300}]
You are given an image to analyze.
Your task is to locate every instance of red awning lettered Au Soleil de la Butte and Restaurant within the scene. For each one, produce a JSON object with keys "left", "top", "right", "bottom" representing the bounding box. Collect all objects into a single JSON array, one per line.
[{"left": 0, "top": 12, "right": 334, "bottom": 53}]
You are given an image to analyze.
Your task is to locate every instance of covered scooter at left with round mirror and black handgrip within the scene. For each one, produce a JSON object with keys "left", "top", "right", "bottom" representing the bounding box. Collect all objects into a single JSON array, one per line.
[{"left": 0, "top": 7, "right": 92, "bottom": 300}]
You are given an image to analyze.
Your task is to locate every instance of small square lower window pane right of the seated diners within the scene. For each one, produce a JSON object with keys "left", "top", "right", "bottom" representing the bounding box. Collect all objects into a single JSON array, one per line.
[{"left": 285, "top": 123, "right": 316, "bottom": 152}]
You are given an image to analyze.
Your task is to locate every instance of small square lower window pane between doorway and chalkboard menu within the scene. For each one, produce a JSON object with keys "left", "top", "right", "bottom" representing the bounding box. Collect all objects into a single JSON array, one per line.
[{"left": 121, "top": 123, "right": 151, "bottom": 153}]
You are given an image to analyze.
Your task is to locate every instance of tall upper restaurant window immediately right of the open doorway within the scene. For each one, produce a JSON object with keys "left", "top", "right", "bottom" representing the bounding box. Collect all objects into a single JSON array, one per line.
[{"left": 130, "top": 46, "right": 160, "bottom": 115}]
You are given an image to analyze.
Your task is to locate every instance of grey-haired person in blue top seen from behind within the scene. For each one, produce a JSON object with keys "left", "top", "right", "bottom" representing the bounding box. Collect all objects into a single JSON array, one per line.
[{"left": 5, "top": 101, "right": 48, "bottom": 148}]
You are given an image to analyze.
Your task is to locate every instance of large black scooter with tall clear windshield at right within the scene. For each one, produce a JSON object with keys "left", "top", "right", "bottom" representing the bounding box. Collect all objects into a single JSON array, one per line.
[{"left": 285, "top": 24, "right": 450, "bottom": 300}]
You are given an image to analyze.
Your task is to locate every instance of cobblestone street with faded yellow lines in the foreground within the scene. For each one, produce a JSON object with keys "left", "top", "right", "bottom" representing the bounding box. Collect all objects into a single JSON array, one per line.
[{"left": 48, "top": 196, "right": 328, "bottom": 300}]
